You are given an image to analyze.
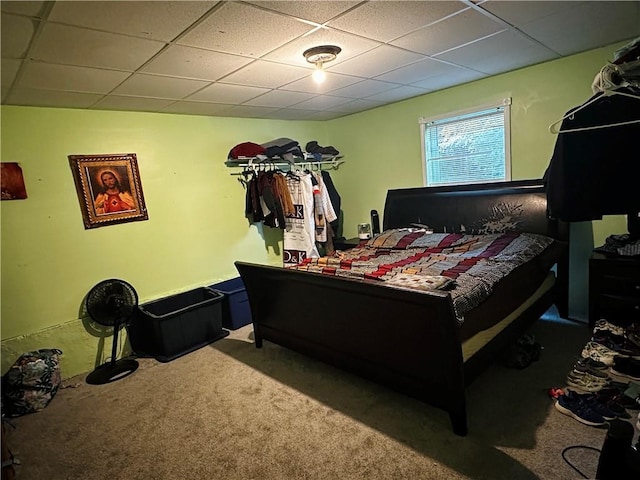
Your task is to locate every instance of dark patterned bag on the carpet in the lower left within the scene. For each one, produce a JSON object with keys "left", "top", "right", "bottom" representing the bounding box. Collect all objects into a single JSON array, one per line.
[{"left": 2, "top": 348, "right": 62, "bottom": 417}]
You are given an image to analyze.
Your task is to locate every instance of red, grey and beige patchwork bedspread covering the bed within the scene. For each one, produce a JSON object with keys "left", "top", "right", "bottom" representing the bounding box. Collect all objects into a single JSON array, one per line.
[{"left": 288, "top": 228, "right": 554, "bottom": 323}]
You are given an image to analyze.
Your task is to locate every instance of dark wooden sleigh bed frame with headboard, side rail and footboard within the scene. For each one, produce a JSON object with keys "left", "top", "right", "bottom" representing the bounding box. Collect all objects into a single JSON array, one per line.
[{"left": 235, "top": 180, "right": 568, "bottom": 435}]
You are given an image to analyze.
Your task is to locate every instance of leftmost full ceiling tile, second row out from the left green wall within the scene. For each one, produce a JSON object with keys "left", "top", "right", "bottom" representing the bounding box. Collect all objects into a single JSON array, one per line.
[{"left": 20, "top": 62, "right": 131, "bottom": 93}]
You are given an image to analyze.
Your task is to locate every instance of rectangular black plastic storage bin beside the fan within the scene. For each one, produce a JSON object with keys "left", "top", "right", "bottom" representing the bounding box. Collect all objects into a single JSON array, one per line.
[{"left": 129, "top": 287, "right": 229, "bottom": 362}]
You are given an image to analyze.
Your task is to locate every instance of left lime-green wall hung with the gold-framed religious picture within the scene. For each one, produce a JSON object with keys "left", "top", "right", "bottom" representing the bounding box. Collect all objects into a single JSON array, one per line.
[{"left": 0, "top": 106, "right": 326, "bottom": 376}]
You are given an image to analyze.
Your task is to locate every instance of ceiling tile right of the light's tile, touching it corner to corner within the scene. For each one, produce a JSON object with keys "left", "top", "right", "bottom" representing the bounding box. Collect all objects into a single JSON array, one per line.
[{"left": 391, "top": 9, "right": 505, "bottom": 55}]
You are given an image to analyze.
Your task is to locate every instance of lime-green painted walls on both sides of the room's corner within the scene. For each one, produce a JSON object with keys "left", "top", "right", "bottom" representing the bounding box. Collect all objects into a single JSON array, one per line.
[{"left": 0, "top": 44, "right": 626, "bottom": 377}]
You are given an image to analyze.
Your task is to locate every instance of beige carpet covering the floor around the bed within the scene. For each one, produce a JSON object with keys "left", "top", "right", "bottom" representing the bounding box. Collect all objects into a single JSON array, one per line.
[{"left": 2, "top": 314, "right": 632, "bottom": 480}]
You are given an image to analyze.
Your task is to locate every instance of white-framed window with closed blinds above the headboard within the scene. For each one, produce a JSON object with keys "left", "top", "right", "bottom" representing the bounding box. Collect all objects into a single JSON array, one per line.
[{"left": 420, "top": 98, "right": 511, "bottom": 187}]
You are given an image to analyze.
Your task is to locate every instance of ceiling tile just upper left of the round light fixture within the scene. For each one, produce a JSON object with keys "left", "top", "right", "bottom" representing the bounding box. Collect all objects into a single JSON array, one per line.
[{"left": 178, "top": 2, "right": 315, "bottom": 57}]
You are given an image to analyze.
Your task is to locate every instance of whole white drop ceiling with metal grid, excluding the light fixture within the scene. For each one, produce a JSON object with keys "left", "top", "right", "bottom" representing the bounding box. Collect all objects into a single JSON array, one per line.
[{"left": 1, "top": 0, "right": 640, "bottom": 120}]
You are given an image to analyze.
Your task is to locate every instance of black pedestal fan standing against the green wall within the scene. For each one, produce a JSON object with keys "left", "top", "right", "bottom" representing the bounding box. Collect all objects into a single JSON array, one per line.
[{"left": 86, "top": 278, "right": 138, "bottom": 385}]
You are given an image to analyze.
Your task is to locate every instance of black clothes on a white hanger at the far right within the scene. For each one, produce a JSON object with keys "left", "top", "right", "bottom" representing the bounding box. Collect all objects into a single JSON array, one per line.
[{"left": 544, "top": 87, "right": 640, "bottom": 222}]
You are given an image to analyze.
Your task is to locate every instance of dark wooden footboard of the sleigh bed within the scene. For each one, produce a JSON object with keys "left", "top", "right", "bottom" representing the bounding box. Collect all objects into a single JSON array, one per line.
[{"left": 235, "top": 262, "right": 467, "bottom": 435}]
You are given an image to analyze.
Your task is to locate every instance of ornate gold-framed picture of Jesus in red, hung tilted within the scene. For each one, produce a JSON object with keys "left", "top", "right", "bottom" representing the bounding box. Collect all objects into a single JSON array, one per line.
[{"left": 68, "top": 153, "right": 149, "bottom": 229}]
